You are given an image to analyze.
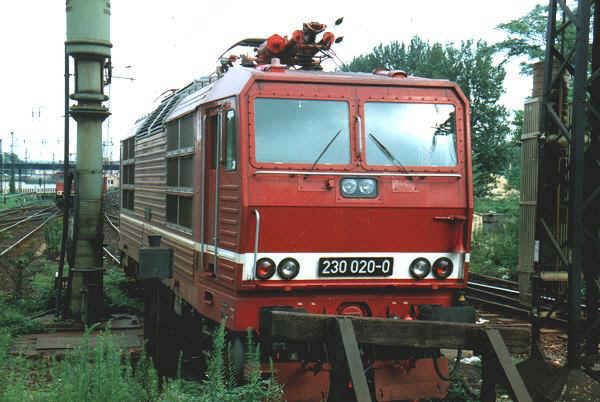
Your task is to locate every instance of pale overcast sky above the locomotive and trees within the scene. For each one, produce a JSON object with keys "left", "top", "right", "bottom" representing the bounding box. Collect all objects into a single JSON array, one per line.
[{"left": 0, "top": 0, "right": 545, "bottom": 160}]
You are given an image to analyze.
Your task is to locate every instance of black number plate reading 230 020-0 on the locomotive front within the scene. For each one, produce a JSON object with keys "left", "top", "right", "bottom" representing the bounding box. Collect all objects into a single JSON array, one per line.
[{"left": 319, "top": 257, "right": 394, "bottom": 277}]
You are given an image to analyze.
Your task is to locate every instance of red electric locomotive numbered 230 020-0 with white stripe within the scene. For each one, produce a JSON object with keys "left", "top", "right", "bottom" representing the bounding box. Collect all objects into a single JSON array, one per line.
[{"left": 120, "top": 23, "right": 473, "bottom": 401}]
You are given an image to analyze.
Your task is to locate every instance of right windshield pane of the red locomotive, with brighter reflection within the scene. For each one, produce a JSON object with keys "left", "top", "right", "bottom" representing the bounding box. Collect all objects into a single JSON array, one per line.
[{"left": 365, "top": 102, "right": 456, "bottom": 167}]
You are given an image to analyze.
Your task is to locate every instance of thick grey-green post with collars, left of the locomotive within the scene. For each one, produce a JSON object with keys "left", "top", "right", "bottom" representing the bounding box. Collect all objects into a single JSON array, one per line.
[{"left": 66, "top": 0, "right": 112, "bottom": 323}]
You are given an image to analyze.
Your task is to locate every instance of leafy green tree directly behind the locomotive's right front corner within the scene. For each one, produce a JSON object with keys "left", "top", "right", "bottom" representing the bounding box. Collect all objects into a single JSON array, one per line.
[{"left": 342, "top": 36, "right": 510, "bottom": 196}]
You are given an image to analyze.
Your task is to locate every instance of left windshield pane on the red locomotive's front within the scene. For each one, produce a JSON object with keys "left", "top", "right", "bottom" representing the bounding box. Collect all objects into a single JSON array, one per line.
[{"left": 254, "top": 98, "right": 350, "bottom": 165}]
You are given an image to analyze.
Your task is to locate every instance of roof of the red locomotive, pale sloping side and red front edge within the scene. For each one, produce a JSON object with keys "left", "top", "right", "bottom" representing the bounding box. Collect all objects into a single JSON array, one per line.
[{"left": 133, "top": 67, "right": 462, "bottom": 136}]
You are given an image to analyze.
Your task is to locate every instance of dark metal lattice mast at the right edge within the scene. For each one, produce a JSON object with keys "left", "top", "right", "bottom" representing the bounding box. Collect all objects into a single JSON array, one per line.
[{"left": 532, "top": 0, "right": 600, "bottom": 369}]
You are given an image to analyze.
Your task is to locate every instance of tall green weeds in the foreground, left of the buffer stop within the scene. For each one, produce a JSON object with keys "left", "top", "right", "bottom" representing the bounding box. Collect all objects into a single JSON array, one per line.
[{"left": 0, "top": 325, "right": 283, "bottom": 402}]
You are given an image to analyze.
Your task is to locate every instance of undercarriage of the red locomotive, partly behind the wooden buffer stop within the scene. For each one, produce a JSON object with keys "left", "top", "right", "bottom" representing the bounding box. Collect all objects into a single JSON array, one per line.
[{"left": 138, "top": 280, "right": 472, "bottom": 401}]
